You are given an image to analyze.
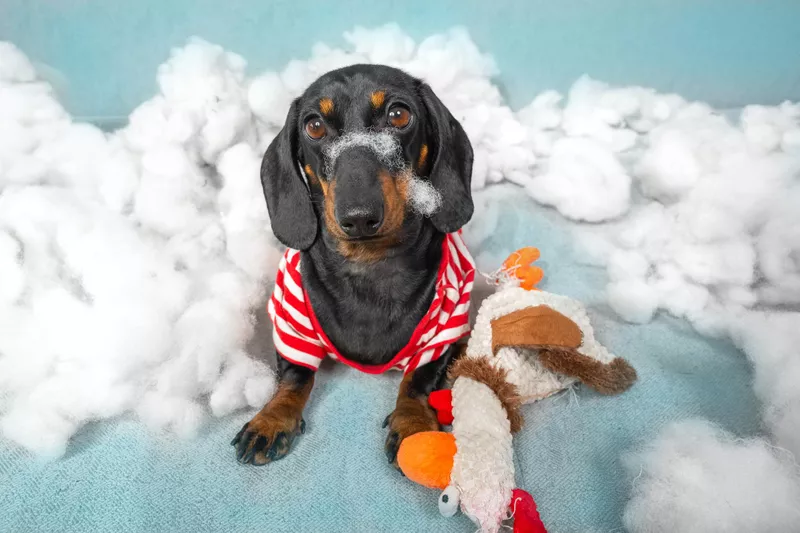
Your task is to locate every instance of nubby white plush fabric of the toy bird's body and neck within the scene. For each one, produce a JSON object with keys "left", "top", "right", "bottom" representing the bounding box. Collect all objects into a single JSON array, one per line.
[{"left": 450, "top": 285, "right": 614, "bottom": 533}]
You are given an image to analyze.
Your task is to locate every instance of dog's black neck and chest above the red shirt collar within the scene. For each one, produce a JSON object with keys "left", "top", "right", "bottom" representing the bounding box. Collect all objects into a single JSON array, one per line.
[{"left": 301, "top": 219, "right": 444, "bottom": 364}]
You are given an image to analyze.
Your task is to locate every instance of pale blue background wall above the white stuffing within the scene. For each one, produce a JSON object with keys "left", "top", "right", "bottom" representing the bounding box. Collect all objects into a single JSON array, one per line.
[{"left": 0, "top": 0, "right": 800, "bottom": 121}]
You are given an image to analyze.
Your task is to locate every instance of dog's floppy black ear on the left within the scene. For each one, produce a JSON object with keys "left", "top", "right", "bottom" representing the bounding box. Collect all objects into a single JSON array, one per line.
[{"left": 261, "top": 100, "right": 317, "bottom": 250}]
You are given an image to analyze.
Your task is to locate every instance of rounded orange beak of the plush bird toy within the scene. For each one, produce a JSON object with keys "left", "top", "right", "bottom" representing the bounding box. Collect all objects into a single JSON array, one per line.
[{"left": 397, "top": 431, "right": 456, "bottom": 490}]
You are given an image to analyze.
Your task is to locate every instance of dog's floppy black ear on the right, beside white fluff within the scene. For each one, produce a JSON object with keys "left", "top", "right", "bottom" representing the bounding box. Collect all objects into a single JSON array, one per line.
[{"left": 420, "top": 83, "right": 474, "bottom": 233}]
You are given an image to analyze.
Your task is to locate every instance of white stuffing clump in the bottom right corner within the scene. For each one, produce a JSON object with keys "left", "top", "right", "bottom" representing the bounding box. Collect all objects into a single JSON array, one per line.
[{"left": 623, "top": 420, "right": 800, "bottom": 533}]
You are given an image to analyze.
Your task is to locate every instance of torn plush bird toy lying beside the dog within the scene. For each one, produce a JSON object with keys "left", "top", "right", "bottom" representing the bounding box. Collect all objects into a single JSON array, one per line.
[{"left": 397, "top": 248, "right": 636, "bottom": 533}]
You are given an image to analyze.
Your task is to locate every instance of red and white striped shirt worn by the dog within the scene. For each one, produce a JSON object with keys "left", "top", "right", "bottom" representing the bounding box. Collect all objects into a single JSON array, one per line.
[{"left": 267, "top": 231, "right": 475, "bottom": 374}]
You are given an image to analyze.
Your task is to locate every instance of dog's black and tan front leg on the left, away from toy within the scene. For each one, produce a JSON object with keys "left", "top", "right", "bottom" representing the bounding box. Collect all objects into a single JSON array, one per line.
[{"left": 231, "top": 356, "right": 315, "bottom": 466}]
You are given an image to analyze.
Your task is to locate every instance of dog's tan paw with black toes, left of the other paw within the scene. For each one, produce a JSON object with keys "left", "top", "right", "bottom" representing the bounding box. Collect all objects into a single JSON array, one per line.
[{"left": 231, "top": 406, "right": 306, "bottom": 466}]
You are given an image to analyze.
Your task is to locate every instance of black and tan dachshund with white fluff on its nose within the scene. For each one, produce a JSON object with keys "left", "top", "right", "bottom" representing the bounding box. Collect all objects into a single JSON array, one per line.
[{"left": 232, "top": 65, "right": 473, "bottom": 465}]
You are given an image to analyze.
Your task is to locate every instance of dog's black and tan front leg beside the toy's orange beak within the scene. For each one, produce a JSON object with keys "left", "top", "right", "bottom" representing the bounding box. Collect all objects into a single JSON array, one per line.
[{"left": 383, "top": 345, "right": 463, "bottom": 468}]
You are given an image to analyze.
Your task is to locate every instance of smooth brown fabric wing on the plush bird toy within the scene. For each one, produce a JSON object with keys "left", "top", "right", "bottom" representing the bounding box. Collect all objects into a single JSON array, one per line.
[{"left": 492, "top": 305, "right": 583, "bottom": 354}]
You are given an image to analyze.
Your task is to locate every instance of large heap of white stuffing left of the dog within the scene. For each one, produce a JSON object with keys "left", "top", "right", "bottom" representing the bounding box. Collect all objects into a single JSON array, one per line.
[{"left": 0, "top": 40, "right": 280, "bottom": 457}]
